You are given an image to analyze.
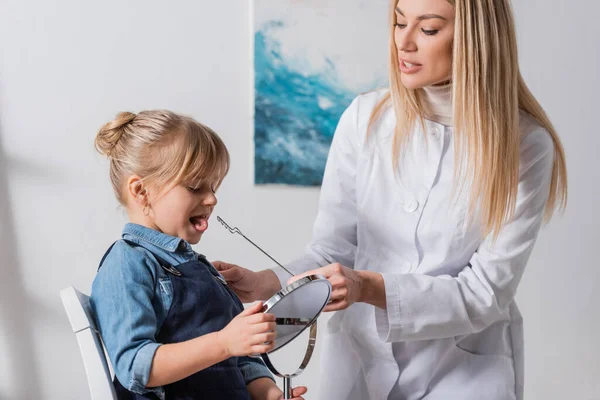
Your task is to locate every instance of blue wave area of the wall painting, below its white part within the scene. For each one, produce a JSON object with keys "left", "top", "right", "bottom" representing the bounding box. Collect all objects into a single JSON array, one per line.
[{"left": 254, "top": 21, "right": 356, "bottom": 186}]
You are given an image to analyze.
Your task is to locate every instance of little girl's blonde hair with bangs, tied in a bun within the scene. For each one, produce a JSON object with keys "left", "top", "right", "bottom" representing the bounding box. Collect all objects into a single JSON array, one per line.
[{"left": 94, "top": 110, "right": 229, "bottom": 205}]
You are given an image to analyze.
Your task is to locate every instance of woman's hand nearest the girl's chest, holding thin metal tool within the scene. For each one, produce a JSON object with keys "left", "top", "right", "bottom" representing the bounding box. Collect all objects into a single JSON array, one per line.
[{"left": 212, "top": 261, "right": 281, "bottom": 303}]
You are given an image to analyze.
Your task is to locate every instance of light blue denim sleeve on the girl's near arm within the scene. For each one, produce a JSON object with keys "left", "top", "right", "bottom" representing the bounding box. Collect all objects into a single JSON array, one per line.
[{"left": 91, "top": 241, "right": 164, "bottom": 398}]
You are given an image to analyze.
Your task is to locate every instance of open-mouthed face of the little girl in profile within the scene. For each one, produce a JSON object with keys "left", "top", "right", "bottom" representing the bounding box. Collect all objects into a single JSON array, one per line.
[{"left": 144, "top": 181, "right": 217, "bottom": 244}]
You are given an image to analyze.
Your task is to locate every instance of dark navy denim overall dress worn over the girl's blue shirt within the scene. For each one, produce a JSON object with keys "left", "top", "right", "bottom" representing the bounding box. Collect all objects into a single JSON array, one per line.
[{"left": 98, "top": 240, "right": 250, "bottom": 400}]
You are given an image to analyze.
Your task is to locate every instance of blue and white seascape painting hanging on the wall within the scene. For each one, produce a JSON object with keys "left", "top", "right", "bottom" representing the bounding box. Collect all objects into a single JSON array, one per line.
[{"left": 252, "top": 0, "right": 389, "bottom": 186}]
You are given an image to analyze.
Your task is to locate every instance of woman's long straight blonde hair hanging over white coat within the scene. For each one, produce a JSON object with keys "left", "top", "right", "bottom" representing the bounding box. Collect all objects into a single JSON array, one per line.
[{"left": 368, "top": 0, "right": 567, "bottom": 237}]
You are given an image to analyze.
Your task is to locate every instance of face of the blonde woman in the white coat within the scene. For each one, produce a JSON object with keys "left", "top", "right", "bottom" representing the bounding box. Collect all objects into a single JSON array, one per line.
[{"left": 394, "top": 0, "right": 455, "bottom": 89}]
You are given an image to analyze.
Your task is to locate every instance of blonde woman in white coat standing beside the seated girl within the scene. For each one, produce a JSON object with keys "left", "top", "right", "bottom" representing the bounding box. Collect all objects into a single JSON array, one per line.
[{"left": 217, "top": 0, "right": 567, "bottom": 400}]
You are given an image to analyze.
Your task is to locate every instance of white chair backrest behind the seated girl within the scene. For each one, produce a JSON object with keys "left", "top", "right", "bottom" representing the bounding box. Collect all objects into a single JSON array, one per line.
[{"left": 60, "top": 286, "right": 117, "bottom": 400}]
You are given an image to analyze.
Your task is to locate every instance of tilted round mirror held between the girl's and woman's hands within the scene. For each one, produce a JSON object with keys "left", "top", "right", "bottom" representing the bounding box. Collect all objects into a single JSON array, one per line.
[{"left": 263, "top": 275, "right": 331, "bottom": 353}]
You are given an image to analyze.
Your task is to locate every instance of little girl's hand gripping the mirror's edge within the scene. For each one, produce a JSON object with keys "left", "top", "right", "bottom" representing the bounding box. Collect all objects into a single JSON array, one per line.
[{"left": 218, "top": 302, "right": 276, "bottom": 358}]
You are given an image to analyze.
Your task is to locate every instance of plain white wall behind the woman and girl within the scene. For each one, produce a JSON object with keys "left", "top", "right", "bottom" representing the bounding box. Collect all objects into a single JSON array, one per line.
[{"left": 0, "top": 0, "right": 600, "bottom": 400}]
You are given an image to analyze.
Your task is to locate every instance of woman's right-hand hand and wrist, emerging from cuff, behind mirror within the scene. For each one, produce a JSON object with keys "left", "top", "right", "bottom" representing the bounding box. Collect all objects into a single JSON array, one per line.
[{"left": 288, "top": 263, "right": 386, "bottom": 311}]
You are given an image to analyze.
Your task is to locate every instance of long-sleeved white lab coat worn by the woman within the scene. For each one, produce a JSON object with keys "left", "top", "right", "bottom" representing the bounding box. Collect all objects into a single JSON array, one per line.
[{"left": 276, "top": 92, "right": 554, "bottom": 400}]
